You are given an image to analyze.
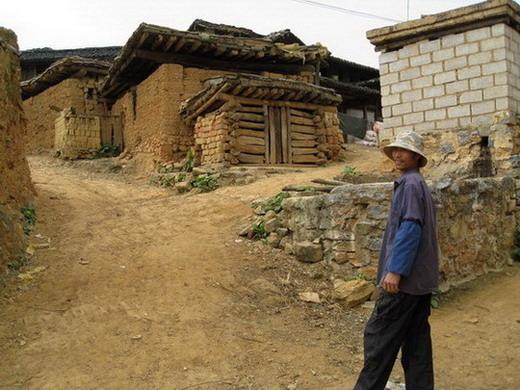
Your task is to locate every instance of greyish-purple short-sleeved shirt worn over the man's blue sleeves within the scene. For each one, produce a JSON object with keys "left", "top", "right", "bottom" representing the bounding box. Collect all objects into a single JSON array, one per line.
[{"left": 377, "top": 170, "right": 439, "bottom": 295}]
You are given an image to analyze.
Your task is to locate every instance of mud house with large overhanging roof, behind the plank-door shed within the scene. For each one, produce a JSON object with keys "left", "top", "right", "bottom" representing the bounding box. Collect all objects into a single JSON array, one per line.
[{"left": 101, "top": 24, "right": 328, "bottom": 166}]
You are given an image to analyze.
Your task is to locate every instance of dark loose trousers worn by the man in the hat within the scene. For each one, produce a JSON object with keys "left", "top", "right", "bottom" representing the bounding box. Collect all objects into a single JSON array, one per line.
[{"left": 354, "top": 289, "right": 433, "bottom": 390}]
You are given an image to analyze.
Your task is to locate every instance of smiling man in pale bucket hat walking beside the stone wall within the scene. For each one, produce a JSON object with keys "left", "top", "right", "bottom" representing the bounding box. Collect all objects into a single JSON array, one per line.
[{"left": 354, "top": 132, "right": 439, "bottom": 390}]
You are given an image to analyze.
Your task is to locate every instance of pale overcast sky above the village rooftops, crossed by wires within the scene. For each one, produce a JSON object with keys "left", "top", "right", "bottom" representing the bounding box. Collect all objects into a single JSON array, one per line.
[{"left": 0, "top": 0, "right": 500, "bottom": 67}]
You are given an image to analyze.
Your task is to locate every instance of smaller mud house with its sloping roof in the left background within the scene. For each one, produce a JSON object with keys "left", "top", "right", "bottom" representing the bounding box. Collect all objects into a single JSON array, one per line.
[{"left": 21, "top": 57, "right": 115, "bottom": 153}]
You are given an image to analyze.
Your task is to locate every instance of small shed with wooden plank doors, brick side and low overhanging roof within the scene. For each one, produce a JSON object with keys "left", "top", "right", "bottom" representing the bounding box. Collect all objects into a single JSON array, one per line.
[{"left": 181, "top": 75, "right": 343, "bottom": 165}]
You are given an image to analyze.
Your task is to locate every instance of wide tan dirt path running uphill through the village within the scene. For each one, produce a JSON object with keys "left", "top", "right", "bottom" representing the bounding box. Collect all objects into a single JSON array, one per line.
[{"left": 0, "top": 154, "right": 520, "bottom": 390}]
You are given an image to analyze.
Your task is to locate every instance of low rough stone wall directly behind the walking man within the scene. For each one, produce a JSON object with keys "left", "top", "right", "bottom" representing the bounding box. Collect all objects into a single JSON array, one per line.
[{"left": 274, "top": 177, "right": 520, "bottom": 288}]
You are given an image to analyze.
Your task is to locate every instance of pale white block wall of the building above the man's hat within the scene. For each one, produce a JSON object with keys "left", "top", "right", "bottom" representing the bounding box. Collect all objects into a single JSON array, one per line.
[{"left": 379, "top": 24, "right": 520, "bottom": 139}]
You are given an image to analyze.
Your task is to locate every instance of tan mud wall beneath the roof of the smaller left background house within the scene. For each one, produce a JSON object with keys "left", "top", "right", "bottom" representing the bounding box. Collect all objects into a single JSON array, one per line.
[{"left": 23, "top": 78, "right": 103, "bottom": 154}]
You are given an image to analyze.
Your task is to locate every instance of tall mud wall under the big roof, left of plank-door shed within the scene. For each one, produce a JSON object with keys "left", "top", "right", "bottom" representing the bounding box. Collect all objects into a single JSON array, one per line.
[{"left": 111, "top": 64, "right": 311, "bottom": 167}]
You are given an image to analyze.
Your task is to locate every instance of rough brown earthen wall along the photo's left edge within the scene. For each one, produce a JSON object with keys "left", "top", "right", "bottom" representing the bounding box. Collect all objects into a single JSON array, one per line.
[{"left": 0, "top": 28, "right": 34, "bottom": 273}]
